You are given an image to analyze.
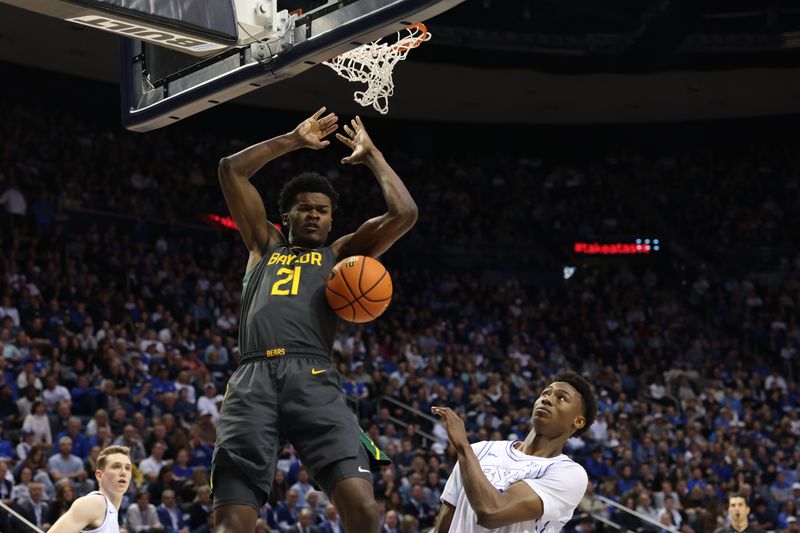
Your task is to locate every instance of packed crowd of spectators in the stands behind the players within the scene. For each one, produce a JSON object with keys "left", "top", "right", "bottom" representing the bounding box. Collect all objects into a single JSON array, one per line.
[{"left": 0, "top": 104, "right": 800, "bottom": 533}]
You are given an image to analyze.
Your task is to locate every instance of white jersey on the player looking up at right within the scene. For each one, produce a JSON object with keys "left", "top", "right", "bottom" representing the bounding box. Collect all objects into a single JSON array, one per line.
[{"left": 442, "top": 440, "right": 589, "bottom": 533}]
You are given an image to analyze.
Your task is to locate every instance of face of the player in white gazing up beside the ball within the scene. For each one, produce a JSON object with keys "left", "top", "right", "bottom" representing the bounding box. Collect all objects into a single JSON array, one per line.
[{"left": 531, "top": 381, "right": 586, "bottom": 437}]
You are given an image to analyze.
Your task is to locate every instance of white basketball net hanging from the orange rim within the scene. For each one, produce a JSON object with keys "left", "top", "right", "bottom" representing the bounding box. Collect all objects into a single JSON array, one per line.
[{"left": 323, "top": 22, "right": 431, "bottom": 115}]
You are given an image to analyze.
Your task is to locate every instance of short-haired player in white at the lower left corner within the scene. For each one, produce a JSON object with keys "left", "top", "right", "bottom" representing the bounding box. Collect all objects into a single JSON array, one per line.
[{"left": 48, "top": 446, "right": 132, "bottom": 533}]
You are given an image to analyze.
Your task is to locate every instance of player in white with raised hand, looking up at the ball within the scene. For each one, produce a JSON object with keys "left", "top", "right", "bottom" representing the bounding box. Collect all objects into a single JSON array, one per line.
[{"left": 431, "top": 372, "right": 597, "bottom": 533}]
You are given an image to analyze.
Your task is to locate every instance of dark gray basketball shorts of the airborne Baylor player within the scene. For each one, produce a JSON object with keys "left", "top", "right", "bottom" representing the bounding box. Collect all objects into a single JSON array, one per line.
[{"left": 211, "top": 355, "right": 372, "bottom": 509}]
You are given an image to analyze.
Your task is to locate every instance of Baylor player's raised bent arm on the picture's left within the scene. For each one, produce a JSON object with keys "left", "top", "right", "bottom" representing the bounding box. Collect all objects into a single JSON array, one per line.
[{"left": 219, "top": 107, "right": 338, "bottom": 270}]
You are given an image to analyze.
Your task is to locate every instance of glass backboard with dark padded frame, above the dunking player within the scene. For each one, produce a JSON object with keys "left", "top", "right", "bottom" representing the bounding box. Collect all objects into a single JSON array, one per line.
[{"left": 120, "top": 0, "right": 464, "bottom": 132}]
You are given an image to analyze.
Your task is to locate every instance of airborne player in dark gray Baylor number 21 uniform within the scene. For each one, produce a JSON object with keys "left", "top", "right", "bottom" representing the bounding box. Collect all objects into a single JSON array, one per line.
[{"left": 211, "top": 107, "right": 417, "bottom": 533}]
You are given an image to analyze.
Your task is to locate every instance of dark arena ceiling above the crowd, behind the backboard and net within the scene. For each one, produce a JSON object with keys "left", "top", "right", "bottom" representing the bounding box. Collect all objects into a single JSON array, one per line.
[{"left": 0, "top": 0, "right": 800, "bottom": 123}]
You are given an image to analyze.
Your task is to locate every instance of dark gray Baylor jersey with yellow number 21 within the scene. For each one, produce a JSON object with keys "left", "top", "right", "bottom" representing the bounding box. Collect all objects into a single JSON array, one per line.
[{"left": 239, "top": 242, "right": 337, "bottom": 358}]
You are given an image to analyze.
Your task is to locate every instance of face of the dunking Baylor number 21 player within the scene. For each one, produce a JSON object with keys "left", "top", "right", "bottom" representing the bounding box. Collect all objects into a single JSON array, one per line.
[{"left": 283, "top": 192, "right": 333, "bottom": 248}]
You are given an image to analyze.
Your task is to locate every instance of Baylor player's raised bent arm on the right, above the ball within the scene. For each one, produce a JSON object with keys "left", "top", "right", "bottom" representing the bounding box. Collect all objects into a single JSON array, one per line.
[{"left": 331, "top": 117, "right": 417, "bottom": 257}]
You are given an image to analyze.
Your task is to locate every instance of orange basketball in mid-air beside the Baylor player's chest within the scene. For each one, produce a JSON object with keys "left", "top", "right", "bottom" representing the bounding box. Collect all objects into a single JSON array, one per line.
[{"left": 325, "top": 255, "right": 392, "bottom": 323}]
